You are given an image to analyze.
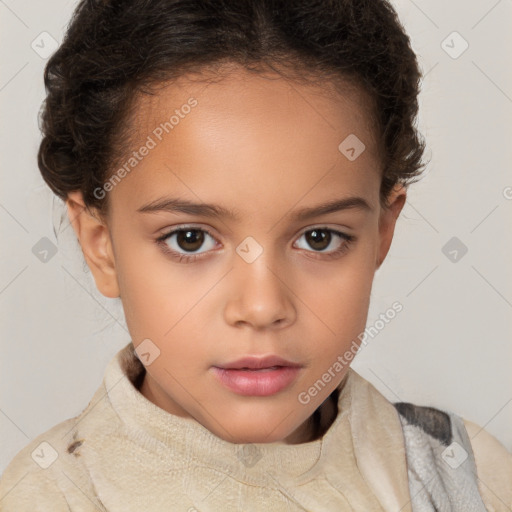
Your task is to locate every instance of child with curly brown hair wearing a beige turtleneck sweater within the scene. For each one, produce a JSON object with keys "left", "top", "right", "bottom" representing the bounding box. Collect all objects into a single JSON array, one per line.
[{"left": 0, "top": 0, "right": 512, "bottom": 512}]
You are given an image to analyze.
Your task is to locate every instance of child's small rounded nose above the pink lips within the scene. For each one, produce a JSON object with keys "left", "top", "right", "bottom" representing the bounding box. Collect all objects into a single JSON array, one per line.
[{"left": 225, "top": 251, "right": 296, "bottom": 330}]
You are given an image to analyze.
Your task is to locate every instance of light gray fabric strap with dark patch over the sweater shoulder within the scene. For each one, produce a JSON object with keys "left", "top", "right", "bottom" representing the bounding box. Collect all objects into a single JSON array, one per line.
[{"left": 394, "top": 402, "right": 486, "bottom": 512}]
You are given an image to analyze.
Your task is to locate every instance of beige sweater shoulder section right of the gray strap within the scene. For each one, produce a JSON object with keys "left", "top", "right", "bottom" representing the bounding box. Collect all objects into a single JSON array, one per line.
[{"left": 463, "top": 419, "right": 512, "bottom": 510}]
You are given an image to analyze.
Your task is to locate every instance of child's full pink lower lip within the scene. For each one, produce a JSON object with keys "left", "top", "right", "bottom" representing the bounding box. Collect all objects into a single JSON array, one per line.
[{"left": 212, "top": 366, "right": 300, "bottom": 396}]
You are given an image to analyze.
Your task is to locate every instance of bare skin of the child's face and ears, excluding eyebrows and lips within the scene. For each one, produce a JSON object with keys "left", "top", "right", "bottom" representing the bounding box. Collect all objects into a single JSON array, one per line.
[{"left": 67, "top": 65, "right": 406, "bottom": 443}]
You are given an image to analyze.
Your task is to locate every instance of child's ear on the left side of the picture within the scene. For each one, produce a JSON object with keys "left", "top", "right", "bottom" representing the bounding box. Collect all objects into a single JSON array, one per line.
[{"left": 66, "top": 191, "right": 119, "bottom": 298}]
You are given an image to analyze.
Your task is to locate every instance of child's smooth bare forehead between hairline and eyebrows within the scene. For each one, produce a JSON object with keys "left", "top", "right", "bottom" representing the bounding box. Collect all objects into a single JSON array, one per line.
[{"left": 113, "top": 64, "right": 380, "bottom": 216}]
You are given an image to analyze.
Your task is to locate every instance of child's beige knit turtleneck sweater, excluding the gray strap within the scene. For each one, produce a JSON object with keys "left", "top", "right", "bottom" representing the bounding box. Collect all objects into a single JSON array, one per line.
[{"left": 0, "top": 343, "right": 512, "bottom": 512}]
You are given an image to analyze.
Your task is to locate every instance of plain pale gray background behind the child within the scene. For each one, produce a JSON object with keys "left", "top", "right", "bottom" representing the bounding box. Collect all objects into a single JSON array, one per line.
[{"left": 0, "top": 0, "right": 512, "bottom": 471}]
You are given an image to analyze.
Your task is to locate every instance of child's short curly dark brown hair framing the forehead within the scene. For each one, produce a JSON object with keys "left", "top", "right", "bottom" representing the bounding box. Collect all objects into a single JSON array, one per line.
[{"left": 38, "top": 0, "right": 426, "bottom": 219}]
